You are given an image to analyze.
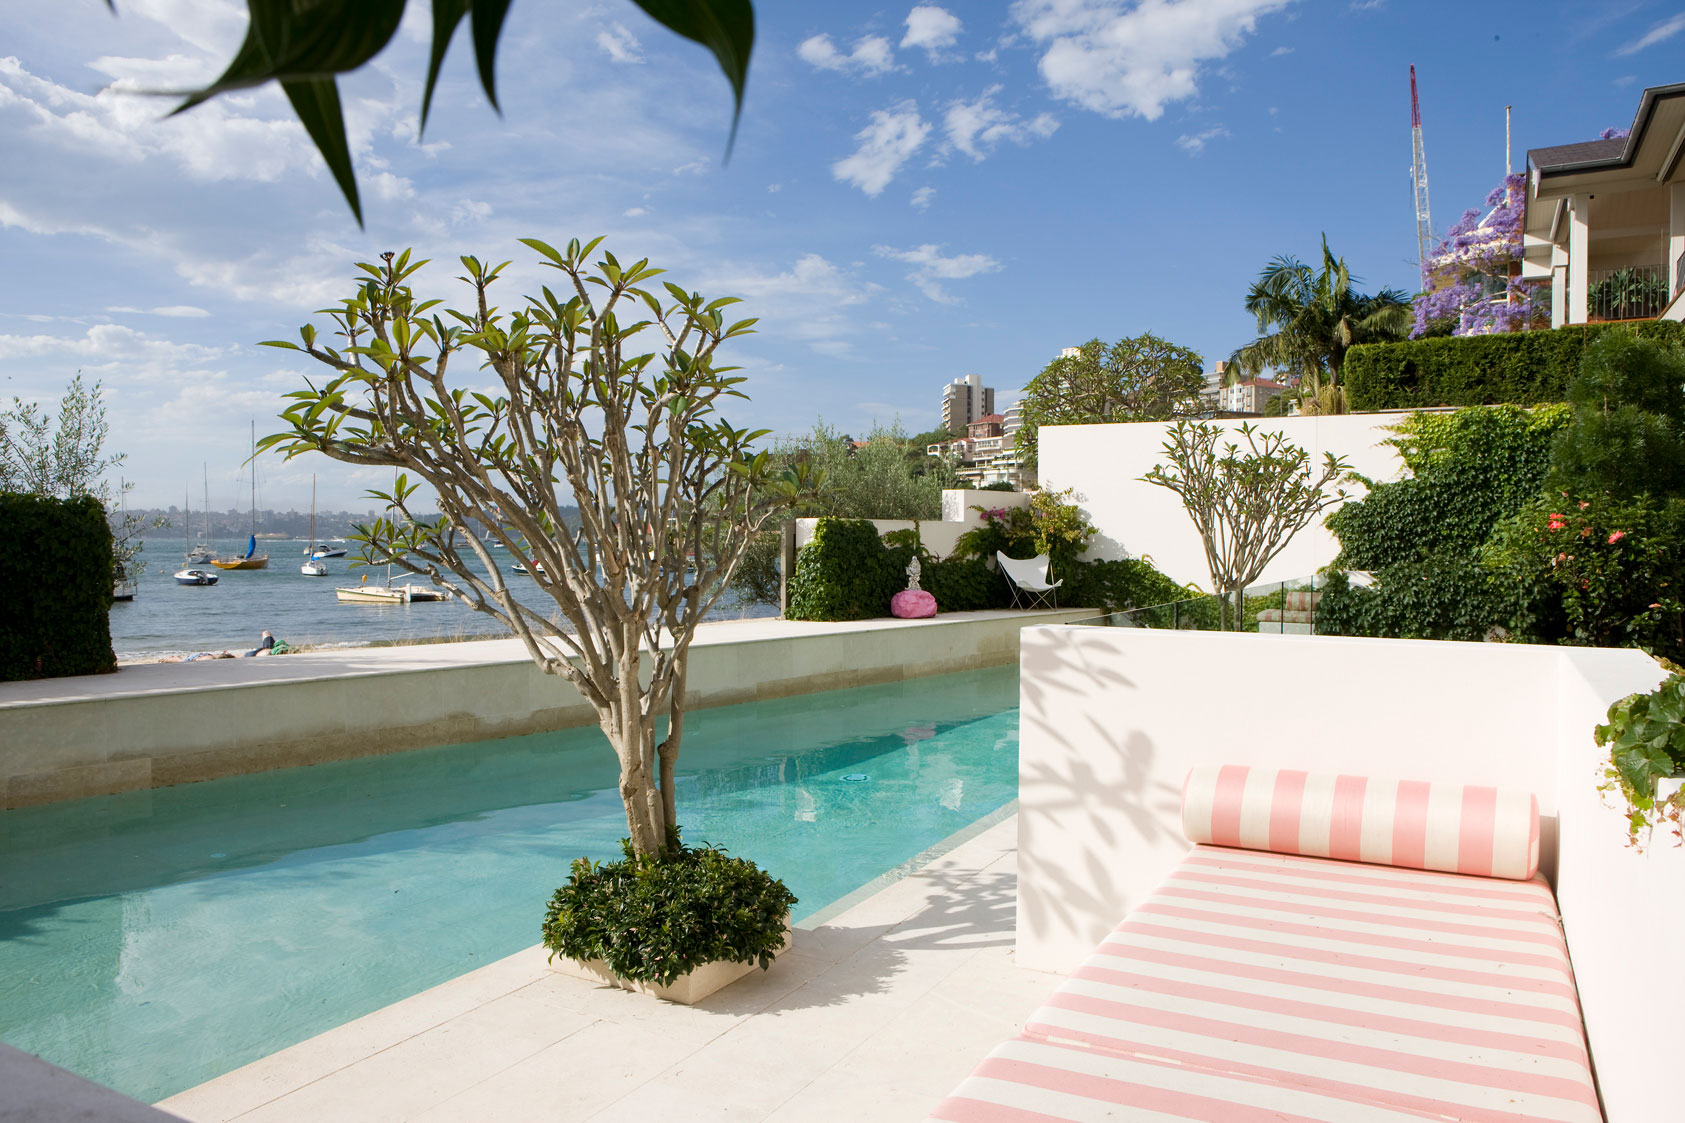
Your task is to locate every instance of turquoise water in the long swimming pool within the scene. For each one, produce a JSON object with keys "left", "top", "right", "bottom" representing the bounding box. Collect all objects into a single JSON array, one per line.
[{"left": 0, "top": 666, "right": 1018, "bottom": 1101}]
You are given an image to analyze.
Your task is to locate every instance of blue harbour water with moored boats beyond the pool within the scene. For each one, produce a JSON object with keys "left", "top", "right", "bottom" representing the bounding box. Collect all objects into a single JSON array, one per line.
[{"left": 111, "top": 538, "right": 777, "bottom": 663}]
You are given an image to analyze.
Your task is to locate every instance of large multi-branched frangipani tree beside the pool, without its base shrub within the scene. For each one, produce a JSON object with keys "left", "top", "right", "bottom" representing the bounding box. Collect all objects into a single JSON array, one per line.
[{"left": 259, "top": 238, "right": 805, "bottom": 853}]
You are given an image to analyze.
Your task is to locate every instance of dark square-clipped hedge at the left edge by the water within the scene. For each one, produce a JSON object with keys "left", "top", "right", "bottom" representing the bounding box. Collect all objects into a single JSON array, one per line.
[{"left": 0, "top": 492, "right": 116, "bottom": 681}]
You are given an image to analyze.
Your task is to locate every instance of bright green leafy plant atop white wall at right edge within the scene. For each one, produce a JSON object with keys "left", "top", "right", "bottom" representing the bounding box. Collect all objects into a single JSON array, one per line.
[{"left": 1596, "top": 659, "right": 1685, "bottom": 846}]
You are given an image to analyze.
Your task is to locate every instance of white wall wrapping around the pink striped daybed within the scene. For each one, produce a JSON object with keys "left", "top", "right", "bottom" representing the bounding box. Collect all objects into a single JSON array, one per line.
[{"left": 1018, "top": 626, "right": 1685, "bottom": 1120}]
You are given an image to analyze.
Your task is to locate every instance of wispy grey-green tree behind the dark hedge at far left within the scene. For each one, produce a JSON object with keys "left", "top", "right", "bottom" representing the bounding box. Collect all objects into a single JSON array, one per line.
[{"left": 0, "top": 374, "right": 159, "bottom": 582}]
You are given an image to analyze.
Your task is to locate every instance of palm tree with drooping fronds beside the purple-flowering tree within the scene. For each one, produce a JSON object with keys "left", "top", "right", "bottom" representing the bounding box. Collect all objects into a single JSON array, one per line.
[{"left": 1228, "top": 234, "right": 1410, "bottom": 413}]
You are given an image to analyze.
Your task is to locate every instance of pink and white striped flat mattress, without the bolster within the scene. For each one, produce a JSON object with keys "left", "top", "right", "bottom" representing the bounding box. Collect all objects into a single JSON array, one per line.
[{"left": 930, "top": 845, "right": 1602, "bottom": 1123}]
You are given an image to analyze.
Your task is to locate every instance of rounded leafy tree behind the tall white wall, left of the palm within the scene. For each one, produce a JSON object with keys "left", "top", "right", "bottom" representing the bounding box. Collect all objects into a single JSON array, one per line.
[{"left": 1016, "top": 332, "right": 1205, "bottom": 465}]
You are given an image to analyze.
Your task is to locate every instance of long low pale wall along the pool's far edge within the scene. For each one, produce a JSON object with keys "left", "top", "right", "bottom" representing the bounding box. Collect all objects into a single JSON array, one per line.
[{"left": 0, "top": 609, "right": 1087, "bottom": 805}]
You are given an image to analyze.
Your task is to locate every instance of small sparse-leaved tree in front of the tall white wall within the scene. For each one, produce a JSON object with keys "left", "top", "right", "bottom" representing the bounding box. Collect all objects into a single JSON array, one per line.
[{"left": 1141, "top": 422, "right": 1350, "bottom": 629}]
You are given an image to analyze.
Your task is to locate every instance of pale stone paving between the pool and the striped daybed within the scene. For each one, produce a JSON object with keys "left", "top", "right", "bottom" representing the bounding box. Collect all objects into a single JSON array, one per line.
[{"left": 158, "top": 818, "right": 1058, "bottom": 1123}]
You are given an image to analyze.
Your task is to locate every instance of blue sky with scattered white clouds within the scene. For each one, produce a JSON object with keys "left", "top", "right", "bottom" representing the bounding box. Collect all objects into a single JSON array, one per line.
[{"left": 0, "top": 0, "right": 1685, "bottom": 509}]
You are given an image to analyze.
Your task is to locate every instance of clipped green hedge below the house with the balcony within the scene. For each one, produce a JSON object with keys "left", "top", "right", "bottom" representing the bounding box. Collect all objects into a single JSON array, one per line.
[{"left": 1341, "top": 320, "right": 1685, "bottom": 411}]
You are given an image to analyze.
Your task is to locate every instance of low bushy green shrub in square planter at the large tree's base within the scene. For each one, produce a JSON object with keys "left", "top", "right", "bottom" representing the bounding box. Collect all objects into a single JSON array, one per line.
[{"left": 544, "top": 828, "right": 795, "bottom": 1005}]
